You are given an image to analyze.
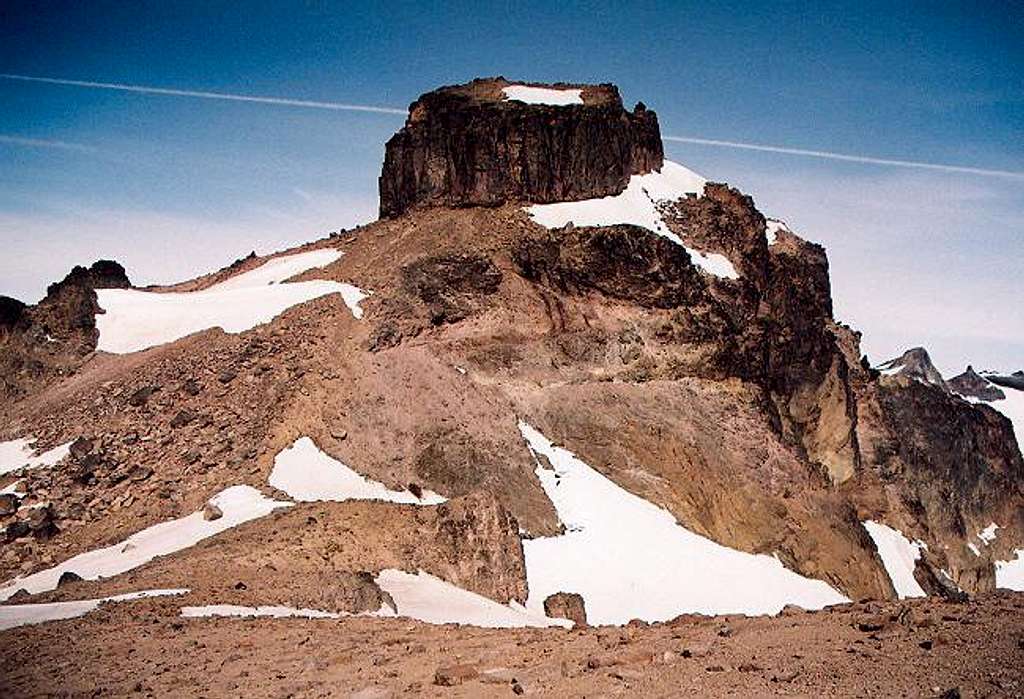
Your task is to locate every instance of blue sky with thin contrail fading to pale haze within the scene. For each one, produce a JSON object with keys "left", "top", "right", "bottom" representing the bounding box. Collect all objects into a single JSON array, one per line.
[{"left": 0, "top": 0, "right": 1024, "bottom": 376}]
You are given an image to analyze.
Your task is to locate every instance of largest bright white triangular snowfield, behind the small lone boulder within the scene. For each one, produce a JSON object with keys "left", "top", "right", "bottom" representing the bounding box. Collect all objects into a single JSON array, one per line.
[{"left": 519, "top": 422, "right": 849, "bottom": 624}]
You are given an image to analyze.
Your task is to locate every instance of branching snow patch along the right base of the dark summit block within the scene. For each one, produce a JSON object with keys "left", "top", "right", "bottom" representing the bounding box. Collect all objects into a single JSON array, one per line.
[{"left": 526, "top": 161, "right": 739, "bottom": 279}]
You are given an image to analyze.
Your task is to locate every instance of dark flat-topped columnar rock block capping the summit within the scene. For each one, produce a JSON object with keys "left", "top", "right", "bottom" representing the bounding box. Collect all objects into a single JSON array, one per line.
[{"left": 380, "top": 78, "right": 663, "bottom": 217}]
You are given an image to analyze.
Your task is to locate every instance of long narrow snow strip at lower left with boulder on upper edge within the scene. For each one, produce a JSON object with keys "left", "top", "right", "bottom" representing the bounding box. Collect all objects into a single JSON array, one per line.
[{"left": 0, "top": 485, "right": 291, "bottom": 601}]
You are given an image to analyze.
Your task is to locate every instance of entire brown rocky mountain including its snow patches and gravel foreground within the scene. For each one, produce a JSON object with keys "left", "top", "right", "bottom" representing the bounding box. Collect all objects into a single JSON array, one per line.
[{"left": 0, "top": 78, "right": 1024, "bottom": 697}]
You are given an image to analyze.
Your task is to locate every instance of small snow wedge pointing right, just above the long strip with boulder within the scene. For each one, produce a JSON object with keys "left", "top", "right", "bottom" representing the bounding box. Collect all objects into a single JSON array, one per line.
[{"left": 268, "top": 437, "right": 447, "bottom": 505}]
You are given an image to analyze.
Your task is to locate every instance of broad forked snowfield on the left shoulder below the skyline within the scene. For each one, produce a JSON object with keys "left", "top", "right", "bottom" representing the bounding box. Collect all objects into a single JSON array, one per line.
[{"left": 96, "top": 249, "right": 368, "bottom": 354}]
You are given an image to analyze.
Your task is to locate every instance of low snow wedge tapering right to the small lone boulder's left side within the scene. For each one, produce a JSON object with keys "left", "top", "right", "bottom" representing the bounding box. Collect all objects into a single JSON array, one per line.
[{"left": 377, "top": 569, "right": 573, "bottom": 628}]
